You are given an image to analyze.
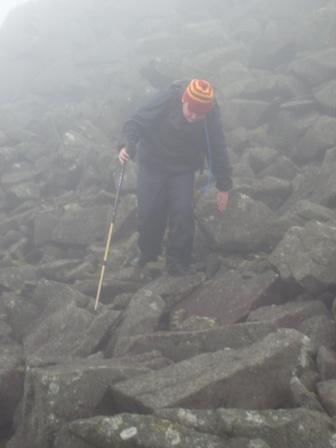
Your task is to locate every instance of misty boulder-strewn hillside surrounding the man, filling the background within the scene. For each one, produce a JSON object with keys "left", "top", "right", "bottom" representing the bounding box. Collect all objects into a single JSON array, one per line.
[{"left": 0, "top": 0, "right": 336, "bottom": 448}]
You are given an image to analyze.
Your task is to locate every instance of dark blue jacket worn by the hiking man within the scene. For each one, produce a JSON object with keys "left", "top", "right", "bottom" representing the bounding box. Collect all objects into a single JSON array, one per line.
[{"left": 121, "top": 81, "right": 232, "bottom": 191}]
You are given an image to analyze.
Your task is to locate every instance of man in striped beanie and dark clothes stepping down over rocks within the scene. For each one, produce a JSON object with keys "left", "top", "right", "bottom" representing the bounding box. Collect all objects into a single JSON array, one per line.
[{"left": 119, "top": 79, "right": 232, "bottom": 276}]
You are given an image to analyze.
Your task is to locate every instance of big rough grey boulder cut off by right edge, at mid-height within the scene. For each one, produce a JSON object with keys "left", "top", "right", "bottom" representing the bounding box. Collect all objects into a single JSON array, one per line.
[{"left": 269, "top": 221, "right": 336, "bottom": 293}]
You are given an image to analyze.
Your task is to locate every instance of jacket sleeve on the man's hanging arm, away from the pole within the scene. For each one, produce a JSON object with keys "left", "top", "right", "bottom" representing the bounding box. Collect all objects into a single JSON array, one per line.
[{"left": 206, "top": 104, "right": 232, "bottom": 191}]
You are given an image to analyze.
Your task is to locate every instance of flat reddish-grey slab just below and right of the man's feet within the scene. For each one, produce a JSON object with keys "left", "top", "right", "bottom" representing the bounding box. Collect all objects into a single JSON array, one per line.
[{"left": 179, "top": 269, "right": 281, "bottom": 324}]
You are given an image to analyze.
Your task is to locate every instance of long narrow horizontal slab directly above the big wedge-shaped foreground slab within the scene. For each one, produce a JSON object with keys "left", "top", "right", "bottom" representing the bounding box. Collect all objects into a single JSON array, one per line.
[{"left": 114, "top": 323, "right": 275, "bottom": 362}]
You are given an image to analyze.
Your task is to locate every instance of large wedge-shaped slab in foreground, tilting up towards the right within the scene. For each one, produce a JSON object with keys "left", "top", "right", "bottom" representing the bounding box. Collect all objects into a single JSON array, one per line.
[{"left": 110, "top": 329, "right": 311, "bottom": 412}]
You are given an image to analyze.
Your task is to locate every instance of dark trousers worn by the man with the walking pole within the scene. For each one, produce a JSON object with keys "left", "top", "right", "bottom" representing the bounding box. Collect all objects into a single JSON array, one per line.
[{"left": 137, "top": 164, "right": 194, "bottom": 265}]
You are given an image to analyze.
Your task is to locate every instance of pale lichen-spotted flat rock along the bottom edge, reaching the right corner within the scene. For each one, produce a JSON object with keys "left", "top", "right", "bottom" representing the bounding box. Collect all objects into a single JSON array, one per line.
[{"left": 155, "top": 408, "right": 334, "bottom": 448}]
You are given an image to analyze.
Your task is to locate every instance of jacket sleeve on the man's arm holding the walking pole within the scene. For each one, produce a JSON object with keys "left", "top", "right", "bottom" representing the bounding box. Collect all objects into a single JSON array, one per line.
[{"left": 119, "top": 89, "right": 171, "bottom": 150}]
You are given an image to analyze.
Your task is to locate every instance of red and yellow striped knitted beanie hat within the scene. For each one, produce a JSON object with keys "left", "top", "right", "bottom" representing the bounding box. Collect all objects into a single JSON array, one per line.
[{"left": 182, "top": 79, "right": 214, "bottom": 115}]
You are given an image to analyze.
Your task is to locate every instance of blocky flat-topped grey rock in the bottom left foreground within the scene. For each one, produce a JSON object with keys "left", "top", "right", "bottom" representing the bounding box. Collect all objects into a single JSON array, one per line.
[{"left": 7, "top": 358, "right": 154, "bottom": 448}]
